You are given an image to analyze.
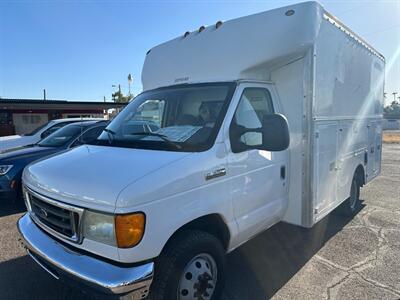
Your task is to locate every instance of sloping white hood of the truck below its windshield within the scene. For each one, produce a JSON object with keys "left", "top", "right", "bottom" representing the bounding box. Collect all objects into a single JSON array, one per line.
[{"left": 23, "top": 145, "right": 190, "bottom": 212}]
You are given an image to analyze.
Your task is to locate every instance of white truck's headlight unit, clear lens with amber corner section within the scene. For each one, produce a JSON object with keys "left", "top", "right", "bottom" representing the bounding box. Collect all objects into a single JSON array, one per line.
[{"left": 83, "top": 211, "right": 145, "bottom": 248}]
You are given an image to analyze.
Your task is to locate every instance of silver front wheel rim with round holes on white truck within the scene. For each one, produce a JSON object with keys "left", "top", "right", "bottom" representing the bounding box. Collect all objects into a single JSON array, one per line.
[{"left": 177, "top": 253, "right": 218, "bottom": 300}]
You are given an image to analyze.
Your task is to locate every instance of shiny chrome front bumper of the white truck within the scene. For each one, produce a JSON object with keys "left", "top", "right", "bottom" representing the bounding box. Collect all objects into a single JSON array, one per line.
[{"left": 18, "top": 214, "right": 154, "bottom": 299}]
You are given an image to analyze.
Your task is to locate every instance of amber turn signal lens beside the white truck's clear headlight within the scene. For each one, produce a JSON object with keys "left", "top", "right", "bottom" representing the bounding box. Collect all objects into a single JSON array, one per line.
[{"left": 115, "top": 213, "right": 145, "bottom": 248}]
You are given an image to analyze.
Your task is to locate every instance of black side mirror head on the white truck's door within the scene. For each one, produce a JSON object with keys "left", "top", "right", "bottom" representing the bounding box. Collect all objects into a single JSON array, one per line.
[{"left": 261, "top": 114, "right": 290, "bottom": 151}]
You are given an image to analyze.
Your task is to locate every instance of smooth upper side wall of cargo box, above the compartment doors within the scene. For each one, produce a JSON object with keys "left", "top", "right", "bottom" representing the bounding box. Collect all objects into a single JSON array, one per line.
[{"left": 314, "top": 14, "right": 384, "bottom": 119}]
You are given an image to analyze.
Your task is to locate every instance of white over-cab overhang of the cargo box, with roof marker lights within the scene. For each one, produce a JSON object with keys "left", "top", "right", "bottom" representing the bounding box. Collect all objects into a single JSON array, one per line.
[{"left": 142, "top": 2, "right": 322, "bottom": 90}]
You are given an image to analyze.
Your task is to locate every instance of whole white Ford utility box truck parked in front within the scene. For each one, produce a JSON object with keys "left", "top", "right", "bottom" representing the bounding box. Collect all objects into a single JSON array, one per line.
[{"left": 18, "top": 2, "right": 385, "bottom": 300}]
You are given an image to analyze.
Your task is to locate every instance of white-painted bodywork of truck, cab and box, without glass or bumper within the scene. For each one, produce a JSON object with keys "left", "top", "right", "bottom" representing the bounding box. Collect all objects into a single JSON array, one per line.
[{"left": 19, "top": 2, "right": 384, "bottom": 268}]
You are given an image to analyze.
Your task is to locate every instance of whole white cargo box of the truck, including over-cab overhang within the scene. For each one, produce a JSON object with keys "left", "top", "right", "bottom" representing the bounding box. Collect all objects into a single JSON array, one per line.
[{"left": 142, "top": 2, "right": 384, "bottom": 227}]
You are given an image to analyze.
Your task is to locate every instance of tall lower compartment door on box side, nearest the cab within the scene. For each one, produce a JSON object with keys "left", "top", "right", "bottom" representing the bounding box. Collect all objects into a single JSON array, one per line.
[{"left": 314, "top": 122, "right": 338, "bottom": 214}]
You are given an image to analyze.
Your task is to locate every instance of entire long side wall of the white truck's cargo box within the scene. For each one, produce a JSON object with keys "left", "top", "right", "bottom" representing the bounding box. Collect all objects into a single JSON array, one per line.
[{"left": 312, "top": 15, "right": 384, "bottom": 222}]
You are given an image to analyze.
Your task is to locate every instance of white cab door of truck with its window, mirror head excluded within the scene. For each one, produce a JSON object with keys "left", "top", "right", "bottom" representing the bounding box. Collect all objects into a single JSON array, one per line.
[{"left": 228, "top": 84, "right": 287, "bottom": 243}]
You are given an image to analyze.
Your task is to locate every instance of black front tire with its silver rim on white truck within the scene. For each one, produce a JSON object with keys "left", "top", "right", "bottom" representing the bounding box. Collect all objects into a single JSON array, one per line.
[{"left": 149, "top": 230, "right": 225, "bottom": 300}]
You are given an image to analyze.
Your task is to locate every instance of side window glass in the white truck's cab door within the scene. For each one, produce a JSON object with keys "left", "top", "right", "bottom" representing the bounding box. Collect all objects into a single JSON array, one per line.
[{"left": 229, "top": 88, "right": 274, "bottom": 153}]
